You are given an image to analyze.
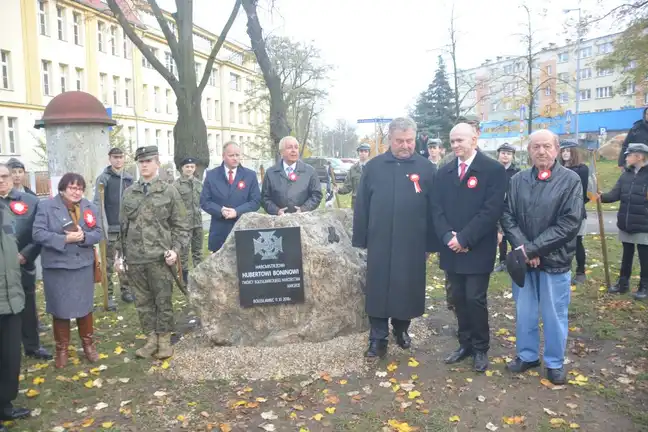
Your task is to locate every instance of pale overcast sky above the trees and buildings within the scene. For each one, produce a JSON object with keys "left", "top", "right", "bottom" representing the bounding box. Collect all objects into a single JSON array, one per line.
[{"left": 160, "top": 0, "right": 617, "bottom": 133}]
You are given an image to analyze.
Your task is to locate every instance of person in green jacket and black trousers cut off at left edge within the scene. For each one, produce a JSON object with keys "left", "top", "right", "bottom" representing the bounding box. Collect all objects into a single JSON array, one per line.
[{"left": 0, "top": 164, "right": 31, "bottom": 432}]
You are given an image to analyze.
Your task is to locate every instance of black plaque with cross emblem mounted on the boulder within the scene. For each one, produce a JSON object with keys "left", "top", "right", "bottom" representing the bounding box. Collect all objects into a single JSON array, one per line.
[{"left": 234, "top": 227, "right": 304, "bottom": 307}]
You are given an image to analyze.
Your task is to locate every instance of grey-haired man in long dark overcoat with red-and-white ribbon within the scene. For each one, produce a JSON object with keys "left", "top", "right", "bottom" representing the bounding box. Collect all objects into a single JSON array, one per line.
[{"left": 352, "top": 118, "right": 439, "bottom": 358}]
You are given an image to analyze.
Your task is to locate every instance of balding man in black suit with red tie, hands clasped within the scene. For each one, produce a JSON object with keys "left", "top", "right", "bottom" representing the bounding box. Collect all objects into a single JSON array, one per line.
[{"left": 432, "top": 123, "right": 508, "bottom": 372}]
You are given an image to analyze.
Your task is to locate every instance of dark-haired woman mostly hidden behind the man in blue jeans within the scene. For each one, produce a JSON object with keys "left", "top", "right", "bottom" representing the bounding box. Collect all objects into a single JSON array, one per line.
[{"left": 558, "top": 140, "right": 589, "bottom": 285}]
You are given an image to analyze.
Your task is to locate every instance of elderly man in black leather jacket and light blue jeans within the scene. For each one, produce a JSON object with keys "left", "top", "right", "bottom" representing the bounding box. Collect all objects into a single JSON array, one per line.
[{"left": 501, "top": 130, "right": 583, "bottom": 384}]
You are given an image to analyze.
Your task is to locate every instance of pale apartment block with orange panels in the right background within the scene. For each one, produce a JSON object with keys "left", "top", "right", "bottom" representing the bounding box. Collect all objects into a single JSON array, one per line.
[{"left": 459, "top": 34, "right": 648, "bottom": 122}]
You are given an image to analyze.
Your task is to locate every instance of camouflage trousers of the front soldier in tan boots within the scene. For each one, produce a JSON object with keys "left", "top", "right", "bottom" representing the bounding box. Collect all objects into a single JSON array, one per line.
[{"left": 128, "top": 261, "right": 174, "bottom": 334}]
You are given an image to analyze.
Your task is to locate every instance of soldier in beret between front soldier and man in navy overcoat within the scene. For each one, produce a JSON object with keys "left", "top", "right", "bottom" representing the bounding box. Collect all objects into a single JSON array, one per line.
[{"left": 174, "top": 157, "right": 204, "bottom": 284}]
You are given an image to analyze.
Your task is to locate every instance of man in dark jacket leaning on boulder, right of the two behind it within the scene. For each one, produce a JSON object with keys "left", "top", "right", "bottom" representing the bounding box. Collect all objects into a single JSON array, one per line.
[{"left": 261, "top": 136, "right": 323, "bottom": 216}]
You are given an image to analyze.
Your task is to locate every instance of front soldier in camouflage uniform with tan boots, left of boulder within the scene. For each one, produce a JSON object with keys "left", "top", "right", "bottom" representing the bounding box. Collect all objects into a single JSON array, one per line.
[{"left": 117, "top": 146, "right": 189, "bottom": 359}]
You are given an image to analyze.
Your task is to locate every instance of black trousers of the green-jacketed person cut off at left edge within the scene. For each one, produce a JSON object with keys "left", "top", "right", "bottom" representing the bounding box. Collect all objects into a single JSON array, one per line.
[{"left": 0, "top": 314, "right": 21, "bottom": 409}]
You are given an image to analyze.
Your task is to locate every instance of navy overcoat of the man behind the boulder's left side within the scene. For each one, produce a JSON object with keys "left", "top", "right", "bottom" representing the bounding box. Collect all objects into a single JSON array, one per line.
[{"left": 200, "top": 165, "right": 261, "bottom": 252}]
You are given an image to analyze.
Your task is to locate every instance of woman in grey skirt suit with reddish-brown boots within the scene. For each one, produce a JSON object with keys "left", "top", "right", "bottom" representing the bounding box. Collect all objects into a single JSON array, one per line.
[{"left": 33, "top": 173, "right": 102, "bottom": 368}]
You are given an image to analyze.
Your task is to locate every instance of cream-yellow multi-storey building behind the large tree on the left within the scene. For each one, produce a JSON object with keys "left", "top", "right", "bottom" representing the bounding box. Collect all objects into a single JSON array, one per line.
[{"left": 0, "top": 0, "right": 266, "bottom": 170}]
